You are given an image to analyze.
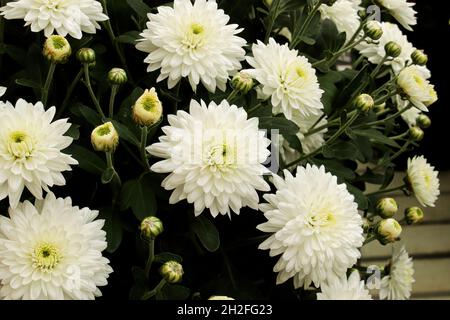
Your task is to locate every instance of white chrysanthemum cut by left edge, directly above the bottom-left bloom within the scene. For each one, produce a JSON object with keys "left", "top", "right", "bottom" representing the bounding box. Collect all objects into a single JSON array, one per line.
[{"left": 0, "top": 99, "right": 78, "bottom": 207}]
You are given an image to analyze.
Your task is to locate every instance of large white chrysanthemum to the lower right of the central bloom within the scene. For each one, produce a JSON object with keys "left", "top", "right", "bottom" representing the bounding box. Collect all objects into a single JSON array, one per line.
[{"left": 258, "top": 164, "right": 364, "bottom": 288}]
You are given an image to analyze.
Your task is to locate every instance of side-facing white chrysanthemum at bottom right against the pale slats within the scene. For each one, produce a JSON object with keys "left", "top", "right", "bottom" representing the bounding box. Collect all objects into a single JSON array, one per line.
[{"left": 380, "top": 247, "right": 415, "bottom": 300}]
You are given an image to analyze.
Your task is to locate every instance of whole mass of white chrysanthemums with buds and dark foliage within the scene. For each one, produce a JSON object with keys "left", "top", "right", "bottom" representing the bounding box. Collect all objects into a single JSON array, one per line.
[{"left": 0, "top": 0, "right": 439, "bottom": 300}]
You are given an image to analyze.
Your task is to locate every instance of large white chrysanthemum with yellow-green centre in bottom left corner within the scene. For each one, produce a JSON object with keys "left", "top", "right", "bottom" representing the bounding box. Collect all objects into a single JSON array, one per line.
[{"left": 0, "top": 193, "right": 112, "bottom": 300}]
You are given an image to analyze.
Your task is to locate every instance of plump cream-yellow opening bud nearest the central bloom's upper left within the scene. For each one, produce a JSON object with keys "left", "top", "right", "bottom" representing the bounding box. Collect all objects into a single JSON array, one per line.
[{"left": 132, "top": 88, "right": 163, "bottom": 127}]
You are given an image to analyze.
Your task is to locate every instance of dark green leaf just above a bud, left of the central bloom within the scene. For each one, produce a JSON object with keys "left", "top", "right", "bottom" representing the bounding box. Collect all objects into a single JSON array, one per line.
[{"left": 120, "top": 176, "right": 156, "bottom": 221}]
